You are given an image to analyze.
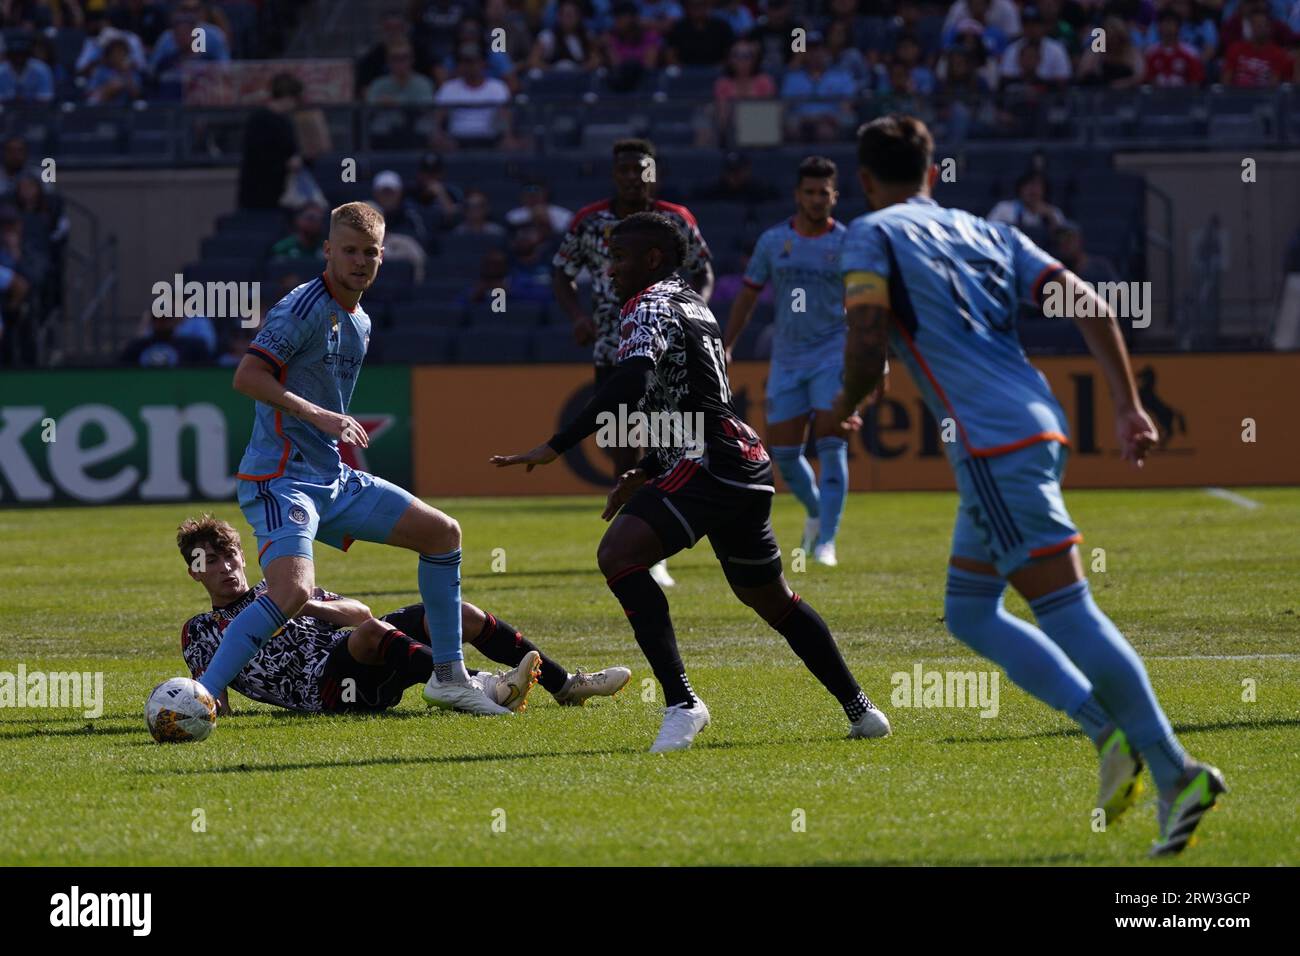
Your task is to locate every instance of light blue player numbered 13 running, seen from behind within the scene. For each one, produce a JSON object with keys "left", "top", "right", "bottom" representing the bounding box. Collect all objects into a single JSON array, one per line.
[{"left": 840, "top": 116, "right": 1226, "bottom": 855}]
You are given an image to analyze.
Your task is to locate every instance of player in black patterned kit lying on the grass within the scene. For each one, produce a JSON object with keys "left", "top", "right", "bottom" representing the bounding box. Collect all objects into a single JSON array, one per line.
[{"left": 177, "top": 515, "right": 632, "bottom": 713}]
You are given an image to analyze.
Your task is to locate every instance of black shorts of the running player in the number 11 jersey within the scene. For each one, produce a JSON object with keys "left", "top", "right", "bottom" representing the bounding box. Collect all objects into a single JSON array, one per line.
[{"left": 621, "top": 460, "right": 781, "bottom": 588}]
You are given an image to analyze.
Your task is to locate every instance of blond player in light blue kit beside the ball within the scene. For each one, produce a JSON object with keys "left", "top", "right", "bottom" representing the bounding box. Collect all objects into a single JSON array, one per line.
[{"left": 199, "top": 203, "right": 511, "bottom": 714}]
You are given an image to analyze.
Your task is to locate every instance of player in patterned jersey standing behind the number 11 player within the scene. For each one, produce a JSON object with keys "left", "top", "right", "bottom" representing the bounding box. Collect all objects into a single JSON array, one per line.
[{"left": 551, "top": 139, "right": 714, "bottom": 588}]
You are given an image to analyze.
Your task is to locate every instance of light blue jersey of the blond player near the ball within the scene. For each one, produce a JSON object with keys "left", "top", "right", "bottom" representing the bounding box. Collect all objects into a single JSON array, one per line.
[{"left": 238, "top": 276, "right": 371, "bottom": 481}]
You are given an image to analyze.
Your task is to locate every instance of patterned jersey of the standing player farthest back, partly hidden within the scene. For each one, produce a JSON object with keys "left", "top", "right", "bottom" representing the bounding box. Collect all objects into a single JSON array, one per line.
[{"left": 551, "top": 199, "right": 710, "bottom": 365}]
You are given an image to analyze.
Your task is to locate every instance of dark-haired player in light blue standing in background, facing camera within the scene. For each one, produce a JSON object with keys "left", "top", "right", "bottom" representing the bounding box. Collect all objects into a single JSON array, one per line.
[{"left": 723, "top": 156, "right": 868, "bottom": 567}]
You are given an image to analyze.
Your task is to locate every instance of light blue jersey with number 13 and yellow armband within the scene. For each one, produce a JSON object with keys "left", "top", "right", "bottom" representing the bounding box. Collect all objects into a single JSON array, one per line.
[{"left": 841, "top": 196, "right": 1069, "bottom": 463}]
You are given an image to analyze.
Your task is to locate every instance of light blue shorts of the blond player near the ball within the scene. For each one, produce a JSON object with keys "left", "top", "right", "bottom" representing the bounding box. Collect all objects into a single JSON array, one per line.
[{"left": 237, "top": 464, "right": 415, "bottom": 568}]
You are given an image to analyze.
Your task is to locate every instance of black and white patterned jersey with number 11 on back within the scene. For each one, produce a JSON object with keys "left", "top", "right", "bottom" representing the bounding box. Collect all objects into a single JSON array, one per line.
[{"left": 618, "top": 276, "right": 775, "bottom": 492}]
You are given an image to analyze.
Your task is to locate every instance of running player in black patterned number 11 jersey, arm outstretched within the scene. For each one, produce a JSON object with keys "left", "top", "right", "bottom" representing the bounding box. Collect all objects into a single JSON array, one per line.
[{"left": 491, "top": 212, "right": 889, "bottom": 753}]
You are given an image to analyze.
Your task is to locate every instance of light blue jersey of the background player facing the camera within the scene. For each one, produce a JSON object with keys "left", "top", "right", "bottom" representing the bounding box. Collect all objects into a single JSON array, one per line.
[{"left": 745, "top": 219, "right": 848, "bottom": 368}]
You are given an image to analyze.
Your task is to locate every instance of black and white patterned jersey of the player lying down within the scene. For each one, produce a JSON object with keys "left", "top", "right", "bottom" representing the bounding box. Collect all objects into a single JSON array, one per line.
[{"left": 181, "top": 581, "right": 346, "bottom": 713}]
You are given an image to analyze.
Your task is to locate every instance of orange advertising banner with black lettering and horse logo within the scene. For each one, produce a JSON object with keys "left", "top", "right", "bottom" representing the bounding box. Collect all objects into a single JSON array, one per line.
[{"left": 411, "top": 354, "right": 1300, "bottom": 497}]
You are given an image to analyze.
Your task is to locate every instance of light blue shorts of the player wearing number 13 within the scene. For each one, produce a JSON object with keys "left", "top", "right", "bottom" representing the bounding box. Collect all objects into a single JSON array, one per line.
[{"left": 953, "top": 441, "right": 1083, "bottom": 578}]
